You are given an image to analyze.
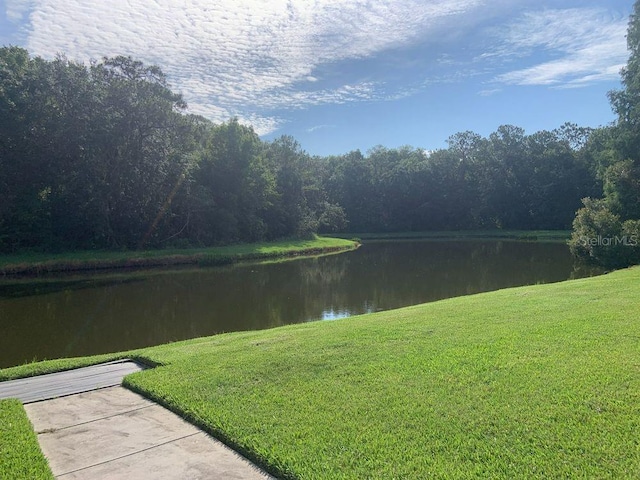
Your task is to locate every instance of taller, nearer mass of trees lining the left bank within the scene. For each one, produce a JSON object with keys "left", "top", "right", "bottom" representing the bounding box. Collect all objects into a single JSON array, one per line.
[{"left": 0, "top": 47, "right": 344, "bottom": 252}]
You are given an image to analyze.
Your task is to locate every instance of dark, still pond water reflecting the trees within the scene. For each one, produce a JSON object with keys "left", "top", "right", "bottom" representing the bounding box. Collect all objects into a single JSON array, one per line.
[{"left": 0, "top": 240, "right": 601, "bottom": 368}]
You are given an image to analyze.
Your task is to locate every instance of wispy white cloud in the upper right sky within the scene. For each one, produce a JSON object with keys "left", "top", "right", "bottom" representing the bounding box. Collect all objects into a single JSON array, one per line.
[{"left": 492, "top": 8, "right": 628, "bottom": 88}]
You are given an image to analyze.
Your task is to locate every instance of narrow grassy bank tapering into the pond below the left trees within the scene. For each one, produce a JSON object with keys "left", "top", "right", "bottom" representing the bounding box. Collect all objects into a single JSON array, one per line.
[{"left": 0, "top": 237, "right": 356, "bottom": 275}]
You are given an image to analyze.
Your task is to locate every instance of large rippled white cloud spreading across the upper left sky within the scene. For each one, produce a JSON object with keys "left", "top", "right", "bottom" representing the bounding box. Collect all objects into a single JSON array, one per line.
[{"left": 11, "top": 0, "right": 483, "bottom": 133}]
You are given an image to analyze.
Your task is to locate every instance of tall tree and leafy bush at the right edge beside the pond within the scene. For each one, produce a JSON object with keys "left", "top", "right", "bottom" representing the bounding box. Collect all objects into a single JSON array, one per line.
[{"left": 570, "top": 1, "right": 640, "bottom": 267}]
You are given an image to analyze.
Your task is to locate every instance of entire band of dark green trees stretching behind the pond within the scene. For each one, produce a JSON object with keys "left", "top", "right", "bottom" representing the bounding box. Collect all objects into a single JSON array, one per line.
[{"left": 0, "top": 32, "right": 640, "bottom": 268}]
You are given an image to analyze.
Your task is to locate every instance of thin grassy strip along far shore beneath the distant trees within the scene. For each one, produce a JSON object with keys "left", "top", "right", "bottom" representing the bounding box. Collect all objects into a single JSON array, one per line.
[{"left": 337, "top": 230, "right": 571, "bottom": 242}]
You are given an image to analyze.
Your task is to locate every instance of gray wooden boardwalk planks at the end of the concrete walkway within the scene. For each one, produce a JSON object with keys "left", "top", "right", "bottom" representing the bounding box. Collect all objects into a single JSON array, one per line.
[{"left": 0, "top": 360, "right": 145, "bottom": 403}]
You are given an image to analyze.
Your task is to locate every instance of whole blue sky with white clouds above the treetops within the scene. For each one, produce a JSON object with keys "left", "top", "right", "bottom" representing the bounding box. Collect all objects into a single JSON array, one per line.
[{"left": 0, "top": 0, "right": 633, "bottom": 155}]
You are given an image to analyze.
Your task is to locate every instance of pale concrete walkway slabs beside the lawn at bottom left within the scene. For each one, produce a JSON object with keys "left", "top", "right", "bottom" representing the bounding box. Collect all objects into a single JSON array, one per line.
[{"left": 25, "top": 387, "right": 273, "bottom": 480}]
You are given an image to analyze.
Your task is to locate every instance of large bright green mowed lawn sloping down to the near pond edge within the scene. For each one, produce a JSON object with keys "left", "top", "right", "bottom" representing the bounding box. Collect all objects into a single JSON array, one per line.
[{"left": 0, "top": 268, "right": 640, "bottom": 479}]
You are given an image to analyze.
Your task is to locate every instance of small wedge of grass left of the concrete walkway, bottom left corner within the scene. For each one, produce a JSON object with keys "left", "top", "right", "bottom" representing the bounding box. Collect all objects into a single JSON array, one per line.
[{"left": 0, "top": 400, "right": 53, "bottom": 480}]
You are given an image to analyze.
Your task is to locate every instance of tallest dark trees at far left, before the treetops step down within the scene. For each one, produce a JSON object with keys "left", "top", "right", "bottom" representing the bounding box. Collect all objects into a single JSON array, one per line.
[{"left": 0, "top": 47, "right": 196, "bottom": 249}]
